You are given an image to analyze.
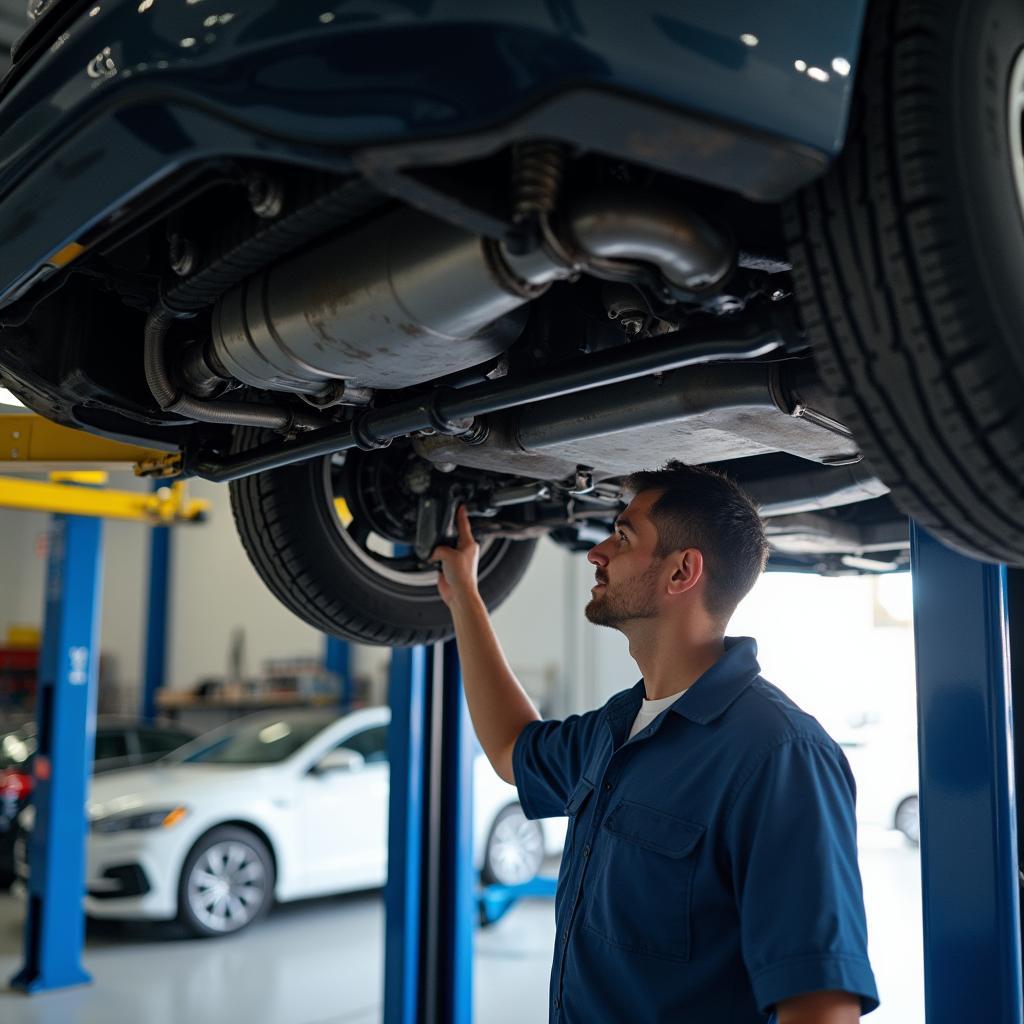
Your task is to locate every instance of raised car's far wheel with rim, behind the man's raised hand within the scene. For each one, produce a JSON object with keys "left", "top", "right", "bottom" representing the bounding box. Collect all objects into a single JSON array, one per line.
[{"left": 230, "top": 430, "right": 537, "bottom": 647}]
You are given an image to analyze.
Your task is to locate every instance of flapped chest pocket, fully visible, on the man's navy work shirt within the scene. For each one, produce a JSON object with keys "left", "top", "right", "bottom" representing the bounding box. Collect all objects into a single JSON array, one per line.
[{"left": 584, "top": 800, "right": 705, "bottom": 961}]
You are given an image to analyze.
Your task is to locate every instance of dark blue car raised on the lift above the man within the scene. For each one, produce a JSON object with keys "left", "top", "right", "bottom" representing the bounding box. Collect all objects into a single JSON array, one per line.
[{"left": 0, "top": 0, "right": 1024, "bottom": 644}]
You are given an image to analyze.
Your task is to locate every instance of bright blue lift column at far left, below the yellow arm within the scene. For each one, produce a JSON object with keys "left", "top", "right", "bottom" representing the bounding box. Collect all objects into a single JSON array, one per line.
[{"left": 11, "top": 515, "right": 102, "bottom": 992}]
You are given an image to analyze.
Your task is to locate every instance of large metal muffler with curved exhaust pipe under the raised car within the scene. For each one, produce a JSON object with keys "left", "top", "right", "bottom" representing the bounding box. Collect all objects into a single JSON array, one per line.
[{"left": 212, "top": 191, "right": 734, "bottom": 394}]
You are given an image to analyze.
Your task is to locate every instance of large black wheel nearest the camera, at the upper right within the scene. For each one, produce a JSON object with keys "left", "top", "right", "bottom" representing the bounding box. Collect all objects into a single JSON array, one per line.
[{"left": 785, "top": 0, "right": 1024, "bottom": 564}]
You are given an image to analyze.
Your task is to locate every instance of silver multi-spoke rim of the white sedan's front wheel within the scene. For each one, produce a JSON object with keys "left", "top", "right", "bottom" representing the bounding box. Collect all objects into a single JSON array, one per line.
[{"left": 187, "top": 840, "right": 266, "bottom": 932}]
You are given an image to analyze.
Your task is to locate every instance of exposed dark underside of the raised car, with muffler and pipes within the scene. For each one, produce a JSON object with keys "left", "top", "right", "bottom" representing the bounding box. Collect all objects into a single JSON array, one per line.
[{"left": 0, "top": 144, "right": 907, "bottom": 593}]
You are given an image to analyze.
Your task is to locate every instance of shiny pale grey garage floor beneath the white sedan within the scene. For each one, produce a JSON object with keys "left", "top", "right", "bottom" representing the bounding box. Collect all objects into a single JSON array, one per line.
[{"left": 0, "top": 833, "right": 924, "bottom": 1024}]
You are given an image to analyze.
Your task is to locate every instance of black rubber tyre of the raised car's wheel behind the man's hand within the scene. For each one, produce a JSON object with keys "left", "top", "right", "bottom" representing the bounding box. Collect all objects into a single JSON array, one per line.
[{"left": 230, "top": 429, "right": 537, "bottom": 647}]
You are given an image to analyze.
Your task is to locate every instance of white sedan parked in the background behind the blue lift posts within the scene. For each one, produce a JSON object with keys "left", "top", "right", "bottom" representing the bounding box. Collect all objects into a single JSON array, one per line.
[{"left": 22, "top": 708, "right": 565, "bottom": 935}]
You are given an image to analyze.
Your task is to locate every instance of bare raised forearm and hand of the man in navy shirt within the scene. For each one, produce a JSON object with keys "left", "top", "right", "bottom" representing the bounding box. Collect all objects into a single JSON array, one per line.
[{"left": 430, "top": 507, "right": 540, "bottom": 783}]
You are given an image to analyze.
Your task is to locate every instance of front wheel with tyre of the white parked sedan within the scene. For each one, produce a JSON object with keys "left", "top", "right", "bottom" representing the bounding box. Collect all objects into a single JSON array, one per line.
[{"left": 178, "top": 825, "right": 274, "bottom": 938}]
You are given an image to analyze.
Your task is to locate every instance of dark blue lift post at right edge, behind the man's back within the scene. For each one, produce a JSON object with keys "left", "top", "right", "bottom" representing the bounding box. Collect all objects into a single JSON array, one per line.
[{"left": 910, "top": 524, "right": 1024, "bottom": 1024}]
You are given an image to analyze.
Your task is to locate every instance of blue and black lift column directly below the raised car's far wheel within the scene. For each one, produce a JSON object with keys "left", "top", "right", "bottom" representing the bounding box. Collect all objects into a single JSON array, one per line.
[{"left": 384, "top": 641, "right": 475, "bottom": 1024}]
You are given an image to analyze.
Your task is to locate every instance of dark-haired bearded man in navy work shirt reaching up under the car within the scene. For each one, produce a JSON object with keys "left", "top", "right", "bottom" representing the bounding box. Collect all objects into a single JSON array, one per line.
[{"left": 432, "top": 463, "right": 879, "bottom": 1024}]
